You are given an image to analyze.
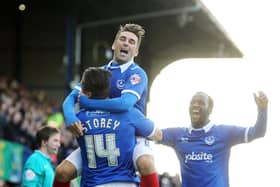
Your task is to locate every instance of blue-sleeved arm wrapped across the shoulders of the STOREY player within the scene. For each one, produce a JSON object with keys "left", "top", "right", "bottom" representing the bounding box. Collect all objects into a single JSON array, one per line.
[{"left": 79, "top": 93, "right": 138, "bottom": 112}]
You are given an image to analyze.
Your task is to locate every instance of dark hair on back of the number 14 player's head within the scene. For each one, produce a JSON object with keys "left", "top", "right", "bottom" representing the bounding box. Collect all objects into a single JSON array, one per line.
[{"left": 82, "top": 67, "right": 111, "bottom": 99}]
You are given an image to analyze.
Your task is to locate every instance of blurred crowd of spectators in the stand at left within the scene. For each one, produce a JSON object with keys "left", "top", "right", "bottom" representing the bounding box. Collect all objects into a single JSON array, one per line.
[{"left": 0, "top": 76, "right": 77, "bottom": 186}]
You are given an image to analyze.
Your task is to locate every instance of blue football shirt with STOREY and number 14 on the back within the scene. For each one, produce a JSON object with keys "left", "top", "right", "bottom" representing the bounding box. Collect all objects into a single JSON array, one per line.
[{"left": 77, "top": 108, "right": 154, "bottom": 187}]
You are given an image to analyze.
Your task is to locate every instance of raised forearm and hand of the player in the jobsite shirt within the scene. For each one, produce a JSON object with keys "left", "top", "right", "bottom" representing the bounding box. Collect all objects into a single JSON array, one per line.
[{"left": 248, "top": 91, "right": 268, "bottom": 141}]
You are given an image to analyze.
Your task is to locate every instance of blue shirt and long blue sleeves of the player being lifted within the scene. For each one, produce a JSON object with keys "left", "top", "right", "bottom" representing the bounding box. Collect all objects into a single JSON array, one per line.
[{"left": 63, "top": 61, "right": 148, "bottom": 126}]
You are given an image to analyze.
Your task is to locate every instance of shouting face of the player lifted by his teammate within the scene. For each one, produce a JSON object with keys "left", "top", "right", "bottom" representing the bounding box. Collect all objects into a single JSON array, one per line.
[{"left": 112, "top": 31, "right": 138, "bottom": 64}]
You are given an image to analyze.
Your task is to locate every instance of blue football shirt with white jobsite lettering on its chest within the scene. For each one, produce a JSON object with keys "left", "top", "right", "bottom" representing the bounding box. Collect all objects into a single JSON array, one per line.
[{"left": 161, "top": 124, "right": 249, "bottom": 187}]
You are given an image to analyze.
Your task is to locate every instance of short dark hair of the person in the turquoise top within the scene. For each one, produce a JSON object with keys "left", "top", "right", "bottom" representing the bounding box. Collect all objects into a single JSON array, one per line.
[{"left": 36, "top": 126, "right": 59, "bottom": 148}]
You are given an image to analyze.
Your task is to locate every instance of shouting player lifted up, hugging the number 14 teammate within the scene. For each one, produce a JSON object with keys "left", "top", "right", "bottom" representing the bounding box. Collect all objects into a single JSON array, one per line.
[{"left": 53, "top": 24, "right": 159, "bottom": 187}]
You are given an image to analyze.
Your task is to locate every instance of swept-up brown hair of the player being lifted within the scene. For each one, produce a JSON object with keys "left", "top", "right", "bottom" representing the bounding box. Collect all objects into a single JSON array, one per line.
[{"left": 115, "top": 23, "right": 146, "bottom": 48}]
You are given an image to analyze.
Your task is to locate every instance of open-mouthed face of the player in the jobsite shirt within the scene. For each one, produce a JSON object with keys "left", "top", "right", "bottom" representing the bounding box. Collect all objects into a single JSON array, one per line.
[{"left": 189, "top": 94, "right": 210, "bottom": 128}]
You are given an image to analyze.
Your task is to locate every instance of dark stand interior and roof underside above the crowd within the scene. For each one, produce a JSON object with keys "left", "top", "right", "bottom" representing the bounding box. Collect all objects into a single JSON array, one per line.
[{"left": 0, "top": 0, "right": 242, "bottom": 100}]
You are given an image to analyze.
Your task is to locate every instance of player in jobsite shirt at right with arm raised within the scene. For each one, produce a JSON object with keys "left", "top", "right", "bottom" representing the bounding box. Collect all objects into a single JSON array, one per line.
[{"left": 157, "top": 92, "right": 268, "bottom": 187}]
